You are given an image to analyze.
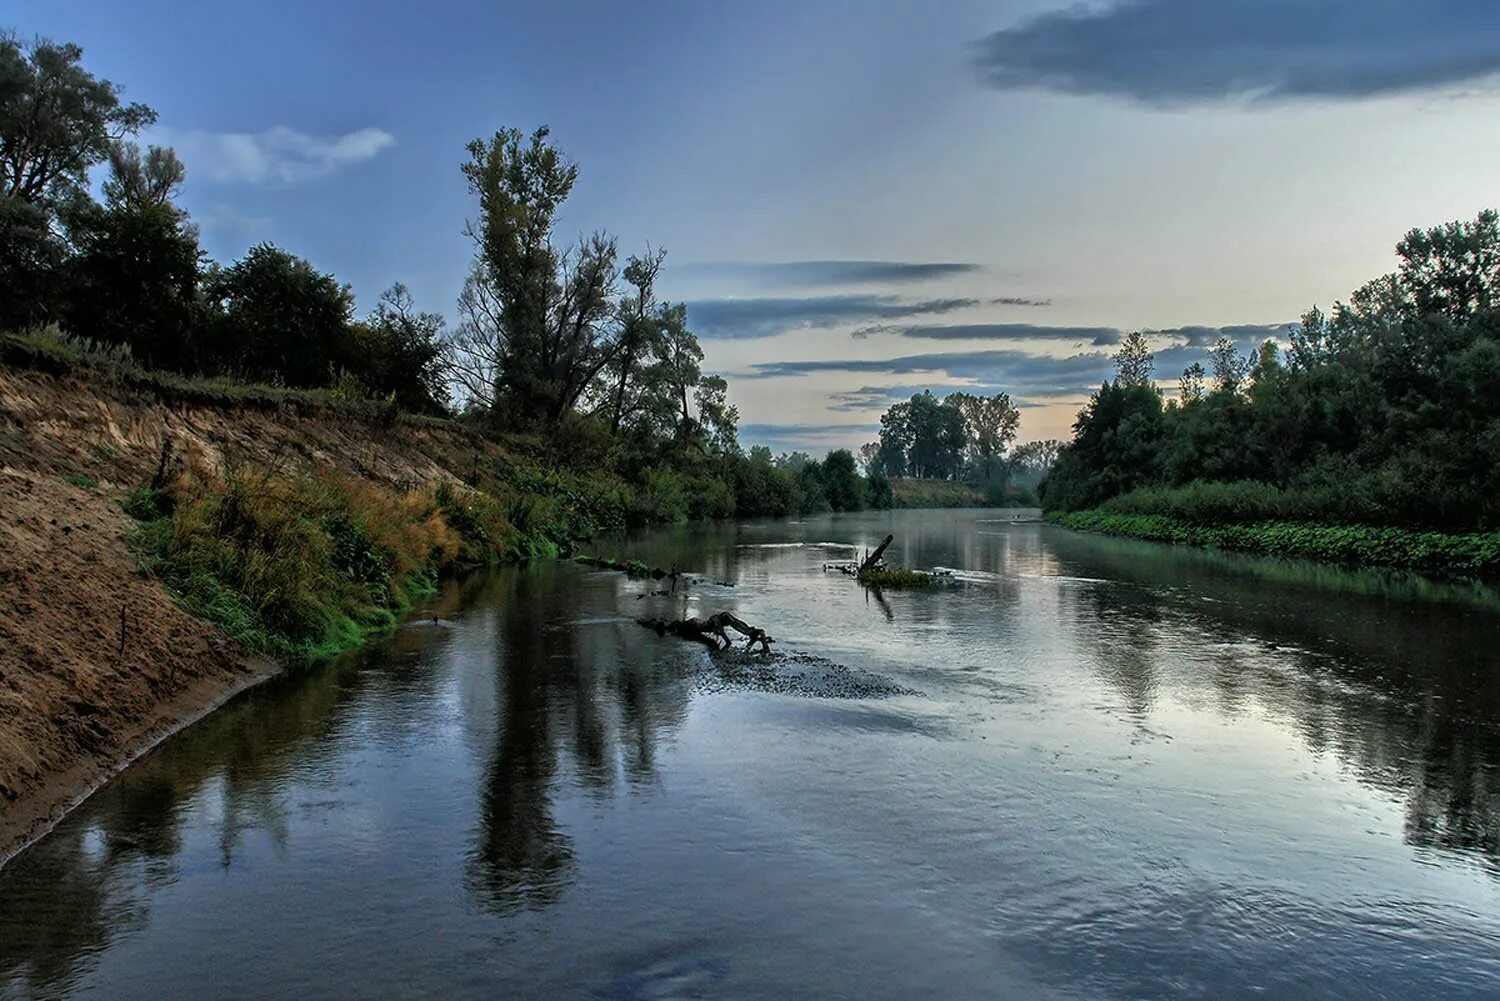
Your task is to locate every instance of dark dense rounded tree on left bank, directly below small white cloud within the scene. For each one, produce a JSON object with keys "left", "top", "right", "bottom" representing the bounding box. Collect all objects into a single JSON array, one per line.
[{"left": 204, "top": 243, "right": 354, "bottom": 386}]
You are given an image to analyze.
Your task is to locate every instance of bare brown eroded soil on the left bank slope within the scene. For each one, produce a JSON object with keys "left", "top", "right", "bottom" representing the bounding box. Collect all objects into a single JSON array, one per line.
[{"left": 0, "top": 368, "right": 474, "bottom": 864}]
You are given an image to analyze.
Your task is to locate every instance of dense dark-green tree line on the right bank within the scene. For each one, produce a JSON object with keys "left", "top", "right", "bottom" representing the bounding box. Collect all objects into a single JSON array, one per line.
[{"left": 1041, "top": 210, "right": 1500, "bottom": 531}]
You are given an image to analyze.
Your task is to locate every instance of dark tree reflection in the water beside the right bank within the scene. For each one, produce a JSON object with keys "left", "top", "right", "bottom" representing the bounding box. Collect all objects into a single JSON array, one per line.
[{"left": 1049, "top": 533, "right": 1500, "bottom": 876}]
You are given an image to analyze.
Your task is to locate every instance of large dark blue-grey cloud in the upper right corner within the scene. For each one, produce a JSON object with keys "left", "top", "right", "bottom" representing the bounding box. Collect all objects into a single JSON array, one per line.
[{"left": 974, "top": 0, "right": 1500, "bottom": 105}]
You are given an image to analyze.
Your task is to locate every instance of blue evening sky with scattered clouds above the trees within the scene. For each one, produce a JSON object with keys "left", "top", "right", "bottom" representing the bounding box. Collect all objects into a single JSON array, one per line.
[{"left": 17, "top": 0, "right": 1500, "bottom": 455}]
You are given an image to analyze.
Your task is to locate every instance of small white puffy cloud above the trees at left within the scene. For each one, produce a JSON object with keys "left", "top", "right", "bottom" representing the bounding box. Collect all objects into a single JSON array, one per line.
[{"left": 152, "top": 125, "right": 396, "bottom": 185}]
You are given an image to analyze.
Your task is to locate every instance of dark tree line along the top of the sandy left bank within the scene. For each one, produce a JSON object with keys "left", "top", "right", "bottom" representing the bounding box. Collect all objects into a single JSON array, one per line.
[{"left": 0, "top": 33, "right": 918, "bottom": 521}]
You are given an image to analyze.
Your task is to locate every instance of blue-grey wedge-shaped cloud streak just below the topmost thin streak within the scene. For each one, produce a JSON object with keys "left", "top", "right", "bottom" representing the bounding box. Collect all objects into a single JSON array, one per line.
[{"left": 687, "top": 294, "right": 990, "bottom": 339}]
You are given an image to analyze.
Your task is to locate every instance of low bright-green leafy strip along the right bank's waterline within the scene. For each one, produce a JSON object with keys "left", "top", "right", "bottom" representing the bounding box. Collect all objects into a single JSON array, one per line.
[{"left": 1046, "top": 509, "right": 1500, "bottom": 579}]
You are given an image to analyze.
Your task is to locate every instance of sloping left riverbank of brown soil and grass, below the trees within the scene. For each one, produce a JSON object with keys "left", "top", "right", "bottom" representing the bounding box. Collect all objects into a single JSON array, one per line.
[{"left": 0, "top": 368, "right": 624, "bottom": 864}]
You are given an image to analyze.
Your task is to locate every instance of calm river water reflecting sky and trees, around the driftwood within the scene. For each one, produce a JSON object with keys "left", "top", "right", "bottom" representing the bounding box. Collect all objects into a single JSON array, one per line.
[{"left": 0, "top": 512, "right": 1500, "bottom": 999}]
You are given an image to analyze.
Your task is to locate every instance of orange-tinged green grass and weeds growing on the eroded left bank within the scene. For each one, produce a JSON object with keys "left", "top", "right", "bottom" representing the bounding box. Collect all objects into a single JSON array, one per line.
[{"left": 122, "top": 468, "right": 591, "bottom": 660}]
